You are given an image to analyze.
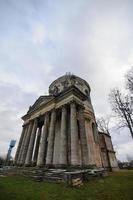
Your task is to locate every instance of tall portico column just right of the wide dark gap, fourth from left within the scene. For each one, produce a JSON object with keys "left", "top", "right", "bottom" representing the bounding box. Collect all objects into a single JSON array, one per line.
[{"left": 37, "top": 113, "right": 49, "bottom": 167}]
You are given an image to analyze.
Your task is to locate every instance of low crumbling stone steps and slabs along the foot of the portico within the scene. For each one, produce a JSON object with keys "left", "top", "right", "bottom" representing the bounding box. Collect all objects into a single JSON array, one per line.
[{"left": 1, "top": 167, "right": 107, "bottom": 185}]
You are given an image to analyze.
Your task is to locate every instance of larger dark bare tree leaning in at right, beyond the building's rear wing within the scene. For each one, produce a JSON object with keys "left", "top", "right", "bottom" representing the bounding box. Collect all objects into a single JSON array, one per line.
[{"left": 109, "top": 89, "right": 133, "bottom": 137}]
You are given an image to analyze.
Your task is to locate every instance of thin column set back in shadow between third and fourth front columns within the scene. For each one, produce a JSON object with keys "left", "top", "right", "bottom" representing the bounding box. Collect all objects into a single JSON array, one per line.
[{"left": 33, "top": 127, "right": 42, "bottom": 164}]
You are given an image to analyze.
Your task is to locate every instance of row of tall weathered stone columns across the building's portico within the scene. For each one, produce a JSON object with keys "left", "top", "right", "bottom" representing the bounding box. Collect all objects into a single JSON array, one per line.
[{"left": 15, "top": 101, "right": 88, "bottom": 167}]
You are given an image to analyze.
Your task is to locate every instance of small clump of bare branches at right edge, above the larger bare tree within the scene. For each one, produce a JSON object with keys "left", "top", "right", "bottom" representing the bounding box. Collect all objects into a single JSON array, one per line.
[{"left": 126, "top": 66, "right": 133, "bottom": 94}]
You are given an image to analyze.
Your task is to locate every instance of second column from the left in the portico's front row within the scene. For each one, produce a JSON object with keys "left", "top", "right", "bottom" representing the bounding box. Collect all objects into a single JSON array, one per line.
[{"left": 20, "top": 122, "right": 33, "bottom": 165}]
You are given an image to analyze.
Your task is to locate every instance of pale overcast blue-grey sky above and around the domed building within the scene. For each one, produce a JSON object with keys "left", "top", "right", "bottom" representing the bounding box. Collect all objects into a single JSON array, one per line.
[{"left": 0, "top": 0, "right": 133, "bottom": 160}]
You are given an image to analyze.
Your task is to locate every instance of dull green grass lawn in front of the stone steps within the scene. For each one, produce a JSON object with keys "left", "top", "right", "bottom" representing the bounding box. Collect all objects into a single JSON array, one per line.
[{"left": 0, "top": 170, "right": 133, "bottom": 200}]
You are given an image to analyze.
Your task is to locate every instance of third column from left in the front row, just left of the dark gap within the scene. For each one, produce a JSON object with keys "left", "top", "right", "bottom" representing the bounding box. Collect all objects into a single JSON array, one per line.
[{"left": 25, "top": 119, "right": 37, "bottom": 166}]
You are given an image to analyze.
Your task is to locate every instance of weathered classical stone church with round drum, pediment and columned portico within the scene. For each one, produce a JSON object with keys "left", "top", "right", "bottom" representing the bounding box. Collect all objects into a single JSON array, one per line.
[{"left": 15, "top": 74, "right": 118, "bottom": 170}]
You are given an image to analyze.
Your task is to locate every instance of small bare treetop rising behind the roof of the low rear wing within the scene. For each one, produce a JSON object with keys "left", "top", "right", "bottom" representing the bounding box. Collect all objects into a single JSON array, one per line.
[{"left": 97, "top": 116, "right": 110, "bottom": 134}]
